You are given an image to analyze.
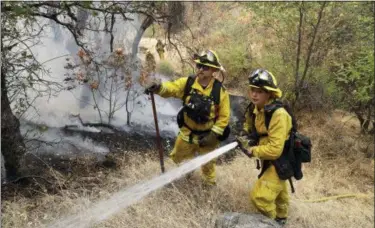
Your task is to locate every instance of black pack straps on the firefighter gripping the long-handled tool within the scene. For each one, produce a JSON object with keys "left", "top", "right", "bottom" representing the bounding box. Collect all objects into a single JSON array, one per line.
[{"left": 177, "top": 75, "right": 230, "bottom": 141}]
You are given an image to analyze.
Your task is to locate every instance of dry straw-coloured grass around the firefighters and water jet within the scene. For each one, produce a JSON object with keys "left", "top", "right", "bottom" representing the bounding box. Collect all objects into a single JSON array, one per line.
[{"left": 2, "top": 112, "right": 374, "bottom": 228}]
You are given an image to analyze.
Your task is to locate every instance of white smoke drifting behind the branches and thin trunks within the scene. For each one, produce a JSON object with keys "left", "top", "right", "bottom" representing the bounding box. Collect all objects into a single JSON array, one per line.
[{"left": 12, "top": 12, "right": 182, "bottom": 159}]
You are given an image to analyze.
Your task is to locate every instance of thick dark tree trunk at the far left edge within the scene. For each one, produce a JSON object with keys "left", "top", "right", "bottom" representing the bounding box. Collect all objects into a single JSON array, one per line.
[{"left": 1, "top": 68, "right": 26, "bottom": 179}]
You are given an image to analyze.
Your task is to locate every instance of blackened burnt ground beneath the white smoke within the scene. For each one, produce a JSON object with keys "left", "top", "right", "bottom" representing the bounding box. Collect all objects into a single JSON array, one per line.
[{"left": 25, "top": 125, "right": 174, "bottom": 173}]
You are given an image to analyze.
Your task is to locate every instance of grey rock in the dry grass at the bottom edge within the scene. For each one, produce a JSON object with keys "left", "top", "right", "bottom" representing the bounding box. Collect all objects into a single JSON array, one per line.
[{"left": 215, "top": 212, "right": 281, "bottom": 228}]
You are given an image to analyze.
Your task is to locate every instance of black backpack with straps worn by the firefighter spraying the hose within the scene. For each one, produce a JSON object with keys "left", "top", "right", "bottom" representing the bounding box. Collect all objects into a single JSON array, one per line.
[{"left": 248, "top": 100, "right": 312, "bottom": 192}]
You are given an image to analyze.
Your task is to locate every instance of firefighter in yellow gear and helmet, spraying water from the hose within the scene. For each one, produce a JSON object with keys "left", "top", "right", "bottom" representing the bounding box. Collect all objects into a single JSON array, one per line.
[{"left": 244, "top": 69, "right": 292, "bottom": 224}]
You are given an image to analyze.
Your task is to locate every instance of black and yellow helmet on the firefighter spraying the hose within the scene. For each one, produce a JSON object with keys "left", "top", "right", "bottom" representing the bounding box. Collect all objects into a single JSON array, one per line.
[{"left": 249, "top": 69, "right": 283, "bottom": 98}]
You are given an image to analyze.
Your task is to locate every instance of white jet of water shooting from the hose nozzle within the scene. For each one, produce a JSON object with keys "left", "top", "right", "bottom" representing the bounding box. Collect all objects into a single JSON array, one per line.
[{"left": 48, "top": 142, "right": 238, "bottom": 228}]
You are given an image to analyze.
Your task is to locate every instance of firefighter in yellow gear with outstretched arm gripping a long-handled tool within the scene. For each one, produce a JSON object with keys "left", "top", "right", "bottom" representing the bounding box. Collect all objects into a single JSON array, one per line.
[{"left": 146, "top": 50, "right": 230, "bottom": 185}]
